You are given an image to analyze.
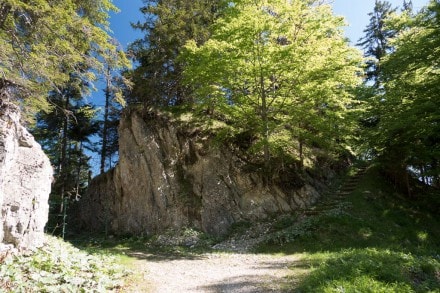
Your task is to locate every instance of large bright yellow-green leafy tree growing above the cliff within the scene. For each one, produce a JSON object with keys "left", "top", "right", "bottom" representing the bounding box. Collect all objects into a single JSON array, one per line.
[{"left": 181, "top": 0, "right": 362, "bottom": 172}]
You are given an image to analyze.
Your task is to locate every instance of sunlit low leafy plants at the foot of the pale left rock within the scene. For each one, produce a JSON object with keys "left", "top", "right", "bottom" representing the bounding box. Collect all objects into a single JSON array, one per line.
[{"left": 0, "top": 236, "right": 127, "bottom": 292}]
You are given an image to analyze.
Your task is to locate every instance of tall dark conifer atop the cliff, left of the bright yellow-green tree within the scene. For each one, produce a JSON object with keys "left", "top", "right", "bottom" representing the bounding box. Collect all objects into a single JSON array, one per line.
[{"left": 129, "top": 0, "right": 222, "bottom": 106}]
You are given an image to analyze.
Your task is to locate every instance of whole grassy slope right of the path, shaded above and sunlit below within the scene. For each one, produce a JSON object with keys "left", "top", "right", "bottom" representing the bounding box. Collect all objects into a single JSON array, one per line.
[{"left": 258, "top": 164, "right": 440, "bottom": 292}]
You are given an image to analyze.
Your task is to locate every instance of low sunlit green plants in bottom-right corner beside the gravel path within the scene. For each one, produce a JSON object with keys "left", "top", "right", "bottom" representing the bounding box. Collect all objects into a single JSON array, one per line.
[{"left": 296, "top": 248, "right": 440, "bottom": 293}]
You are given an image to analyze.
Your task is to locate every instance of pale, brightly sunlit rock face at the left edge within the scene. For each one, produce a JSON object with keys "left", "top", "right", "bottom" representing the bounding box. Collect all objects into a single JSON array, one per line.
[{"left": 0, "top": 100, "right": 52, "bottom": 249}]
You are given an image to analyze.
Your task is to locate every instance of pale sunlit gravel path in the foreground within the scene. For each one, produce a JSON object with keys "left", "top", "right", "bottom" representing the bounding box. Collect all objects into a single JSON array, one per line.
[{"left": 128, "top": 252, "right": 297, "bottom": 293}]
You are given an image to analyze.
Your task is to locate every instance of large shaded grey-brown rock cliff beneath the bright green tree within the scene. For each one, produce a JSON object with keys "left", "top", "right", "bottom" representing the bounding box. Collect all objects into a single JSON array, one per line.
[{"left": 79, "top": 112, "right": 319, "bottom": 235}]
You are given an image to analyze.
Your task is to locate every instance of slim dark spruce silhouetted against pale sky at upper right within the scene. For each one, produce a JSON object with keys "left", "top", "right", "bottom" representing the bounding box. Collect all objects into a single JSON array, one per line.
[{"left": 357, "top": 0, "right": 398, "bottom": 88}]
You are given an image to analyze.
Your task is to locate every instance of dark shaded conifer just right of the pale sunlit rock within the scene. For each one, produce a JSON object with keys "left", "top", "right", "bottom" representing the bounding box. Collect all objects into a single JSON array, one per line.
[{"left": 32, "top": 77, "right": 98, "bottom": 235}]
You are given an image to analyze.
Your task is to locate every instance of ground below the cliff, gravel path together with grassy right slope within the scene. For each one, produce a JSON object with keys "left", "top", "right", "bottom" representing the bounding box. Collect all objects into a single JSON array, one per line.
[{"left": 70, "top": 164, "right": 440, "bottom": 293}]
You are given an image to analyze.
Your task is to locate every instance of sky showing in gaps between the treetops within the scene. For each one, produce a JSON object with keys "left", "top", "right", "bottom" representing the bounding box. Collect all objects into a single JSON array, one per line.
[{"left": 110, "top": 0, "right": 429, "bottom": 48}]
